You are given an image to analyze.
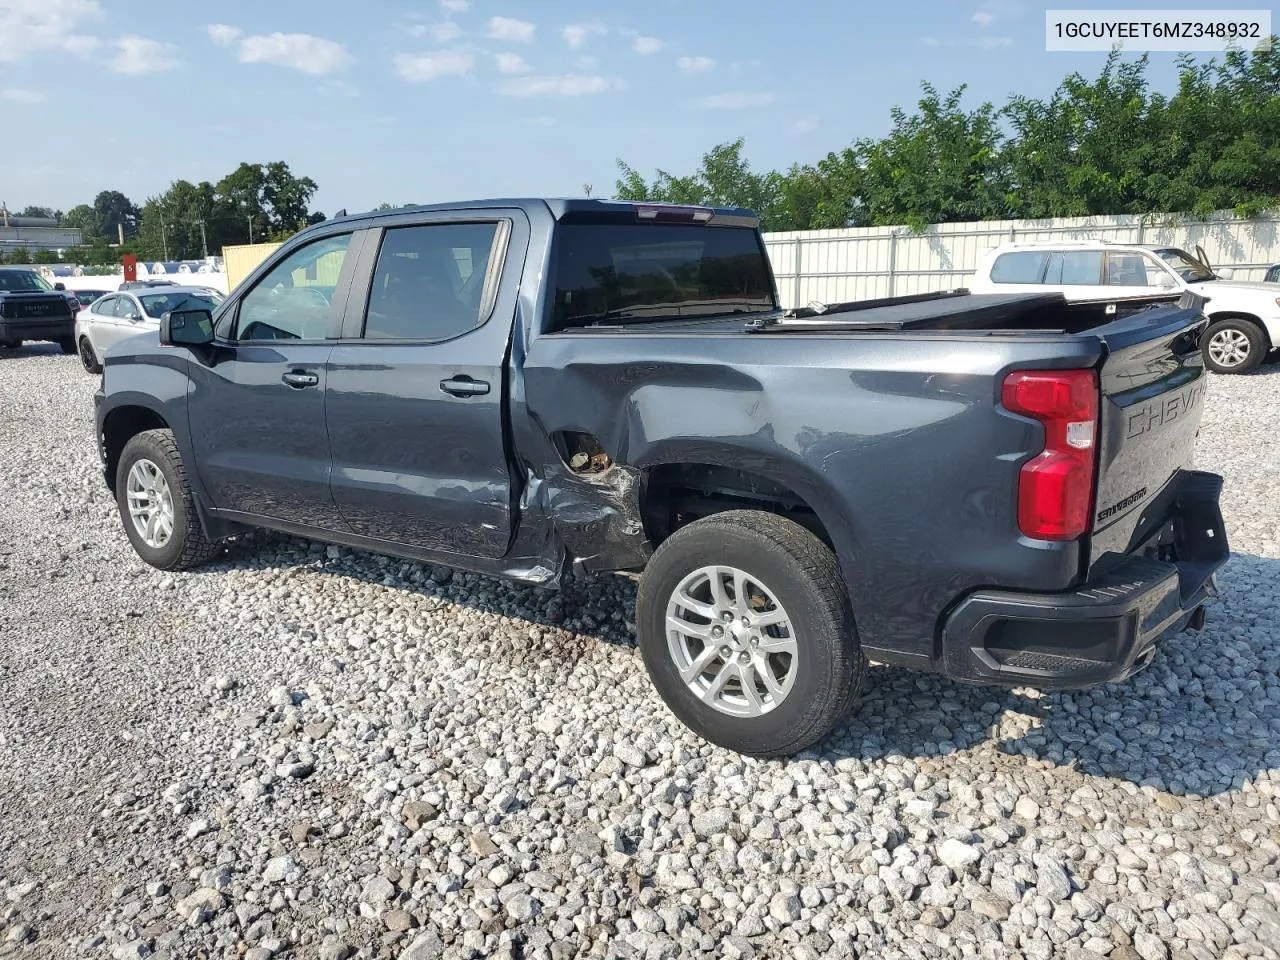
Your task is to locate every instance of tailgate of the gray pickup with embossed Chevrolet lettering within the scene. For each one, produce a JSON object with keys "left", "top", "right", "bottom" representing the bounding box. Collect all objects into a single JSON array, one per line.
[{"left": 1092, "top": 293, "right": 1208, "bottom": 562}]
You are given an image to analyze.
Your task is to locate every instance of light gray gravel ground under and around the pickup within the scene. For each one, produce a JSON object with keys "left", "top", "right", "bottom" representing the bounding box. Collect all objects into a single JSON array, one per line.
[{"left": 0, "top": 347, "right": 1280, "bottom": 960}]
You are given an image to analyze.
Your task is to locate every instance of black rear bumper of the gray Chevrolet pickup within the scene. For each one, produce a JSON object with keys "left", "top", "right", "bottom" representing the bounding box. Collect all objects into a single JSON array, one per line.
[{"left": 942, "top": 471, "right": 1230, "bottom": 689}]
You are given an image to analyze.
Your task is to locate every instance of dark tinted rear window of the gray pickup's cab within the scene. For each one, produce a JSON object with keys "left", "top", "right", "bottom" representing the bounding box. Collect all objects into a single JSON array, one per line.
[{"left": 552, "top": 223, "right": 777, "bottom": 330}]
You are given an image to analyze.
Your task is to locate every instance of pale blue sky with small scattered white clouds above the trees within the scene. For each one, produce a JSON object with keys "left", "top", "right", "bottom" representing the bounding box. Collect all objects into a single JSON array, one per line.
[{"left": 0, "top": 0, "right": 1203, "bottom": 212}]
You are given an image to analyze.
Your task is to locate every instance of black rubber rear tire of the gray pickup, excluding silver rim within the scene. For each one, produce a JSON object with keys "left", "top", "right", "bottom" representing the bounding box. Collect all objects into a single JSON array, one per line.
[{"left": 636, "top": 526, "right": 859, "bottom": 755}]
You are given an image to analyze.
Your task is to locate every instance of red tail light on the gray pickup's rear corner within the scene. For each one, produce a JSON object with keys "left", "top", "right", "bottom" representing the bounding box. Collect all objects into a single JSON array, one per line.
[{"left": 1001, "top": 370, "right": 1098, "bottom": 540}]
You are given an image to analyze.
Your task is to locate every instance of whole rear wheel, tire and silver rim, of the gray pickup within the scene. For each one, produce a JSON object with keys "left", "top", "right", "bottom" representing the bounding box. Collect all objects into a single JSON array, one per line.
[{"left": 636, "top": 511, "right": 865, "bottom": 756}]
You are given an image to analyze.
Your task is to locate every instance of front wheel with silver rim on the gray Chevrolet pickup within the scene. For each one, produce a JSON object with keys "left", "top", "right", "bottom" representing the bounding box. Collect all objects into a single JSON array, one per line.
[{"left": 115, "top": 430, "right": 219, "bottom": 570}]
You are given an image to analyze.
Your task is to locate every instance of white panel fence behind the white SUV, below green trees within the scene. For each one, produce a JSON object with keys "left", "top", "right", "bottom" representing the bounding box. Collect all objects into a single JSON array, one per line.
[{"left": 764, "top": 211, "right": 1280, "bottom": 307}]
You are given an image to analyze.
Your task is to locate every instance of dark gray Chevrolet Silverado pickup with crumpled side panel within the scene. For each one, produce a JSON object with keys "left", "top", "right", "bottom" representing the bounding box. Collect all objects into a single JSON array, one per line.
[{"left": 96, "top": 200, "right": 1228, "bottom": 755}]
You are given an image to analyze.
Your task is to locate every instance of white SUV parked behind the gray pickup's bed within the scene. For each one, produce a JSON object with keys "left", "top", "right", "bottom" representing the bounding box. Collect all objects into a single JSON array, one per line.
[{"left": 969, "top": 241, "right": 1280, "bottom": 374}]
